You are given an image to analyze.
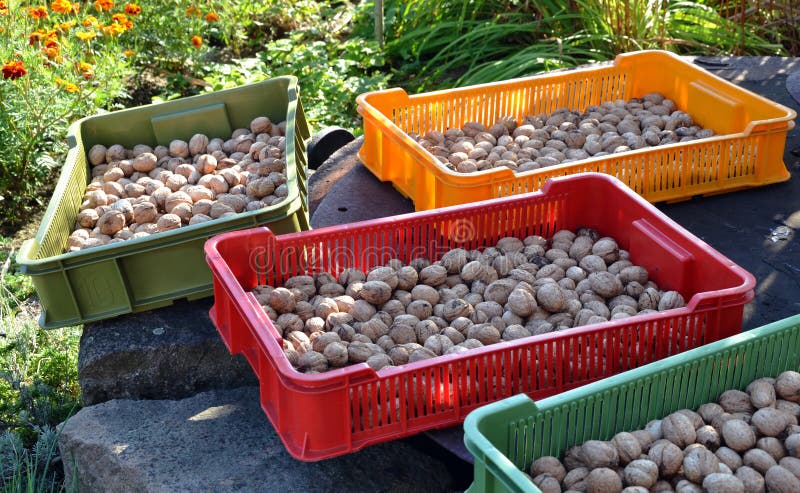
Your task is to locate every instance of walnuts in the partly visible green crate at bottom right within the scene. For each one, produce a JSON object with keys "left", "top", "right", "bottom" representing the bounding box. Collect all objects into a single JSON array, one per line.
[{"left": 530, "top": 371, "right": 800, "bottom": 493}]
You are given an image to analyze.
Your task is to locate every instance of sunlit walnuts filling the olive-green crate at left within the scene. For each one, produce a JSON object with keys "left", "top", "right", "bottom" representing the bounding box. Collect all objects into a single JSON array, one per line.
[{"left": 67, "top": 116, "right": 289, "bottom": 252}]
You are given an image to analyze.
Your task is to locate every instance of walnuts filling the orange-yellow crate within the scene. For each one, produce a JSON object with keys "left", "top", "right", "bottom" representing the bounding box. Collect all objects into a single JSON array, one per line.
[{"left": 409, "top": 93, "right": 714, "bottom": 173}]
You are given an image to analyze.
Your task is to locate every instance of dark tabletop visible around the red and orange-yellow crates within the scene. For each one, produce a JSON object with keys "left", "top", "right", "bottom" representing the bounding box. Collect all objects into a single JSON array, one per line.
[{"left": 311, "top": 57, "right": 800, "bottom": 461}]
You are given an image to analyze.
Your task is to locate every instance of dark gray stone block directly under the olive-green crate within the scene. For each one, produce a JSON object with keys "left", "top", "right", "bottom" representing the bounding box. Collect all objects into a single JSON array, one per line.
[{"left": 78, "top": 298, "right": 257, "bottom": 405}]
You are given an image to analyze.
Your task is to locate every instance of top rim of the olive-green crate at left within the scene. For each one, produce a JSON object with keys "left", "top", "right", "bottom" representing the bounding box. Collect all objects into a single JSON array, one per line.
[{"left": 15, "top": 75, "right": 302, "bottom": 275}]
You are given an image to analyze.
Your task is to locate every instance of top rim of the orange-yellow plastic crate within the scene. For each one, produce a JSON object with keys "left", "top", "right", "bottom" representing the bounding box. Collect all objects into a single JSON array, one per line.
[{"left": 356, "top": 50, "right": 797, "bottom": 183}]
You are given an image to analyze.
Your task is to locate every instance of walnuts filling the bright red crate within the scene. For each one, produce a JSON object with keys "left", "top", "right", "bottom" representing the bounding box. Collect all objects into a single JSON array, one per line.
[{"left": 253, "top": 228, "right": 685, "bottom": 373}]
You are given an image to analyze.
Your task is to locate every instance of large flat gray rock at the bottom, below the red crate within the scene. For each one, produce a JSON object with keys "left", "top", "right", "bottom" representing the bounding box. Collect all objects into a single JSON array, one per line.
[{"left": 59, "top": 387, "right": 453, "bottom": 493}]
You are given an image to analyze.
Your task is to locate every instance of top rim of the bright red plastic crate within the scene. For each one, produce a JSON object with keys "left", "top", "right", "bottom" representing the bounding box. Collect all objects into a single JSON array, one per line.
[{"left": 204, "top": 173, "right": 756, "bottom": 389}]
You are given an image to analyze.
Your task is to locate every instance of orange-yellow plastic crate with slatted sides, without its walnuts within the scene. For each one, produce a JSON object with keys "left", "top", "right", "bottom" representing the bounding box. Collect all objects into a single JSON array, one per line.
[{"left": 357, "top": 51, "right": 796, "bottom": 210}]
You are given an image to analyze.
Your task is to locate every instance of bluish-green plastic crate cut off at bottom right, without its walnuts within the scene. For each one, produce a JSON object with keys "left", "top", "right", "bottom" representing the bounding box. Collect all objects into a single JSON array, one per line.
[{"left": 464, "top": 315, "right": 800, "bottom": 493}]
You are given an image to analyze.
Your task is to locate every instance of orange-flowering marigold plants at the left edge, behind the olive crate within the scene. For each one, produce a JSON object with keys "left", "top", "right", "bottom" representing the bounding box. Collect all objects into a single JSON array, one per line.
[{"left": 0, "top": 2, "right": 134, "bottom": 232}]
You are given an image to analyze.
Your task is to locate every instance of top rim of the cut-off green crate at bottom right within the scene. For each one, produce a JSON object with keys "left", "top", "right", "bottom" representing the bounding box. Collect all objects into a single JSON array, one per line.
[{"left": 463, "top": 314, "right": 800, "bottom": 491}]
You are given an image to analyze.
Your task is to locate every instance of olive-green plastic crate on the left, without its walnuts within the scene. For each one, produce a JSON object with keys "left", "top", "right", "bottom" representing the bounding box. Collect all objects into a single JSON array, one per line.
[{"left": 17, "top": 76, "right": 310, "bottom": 328}]
